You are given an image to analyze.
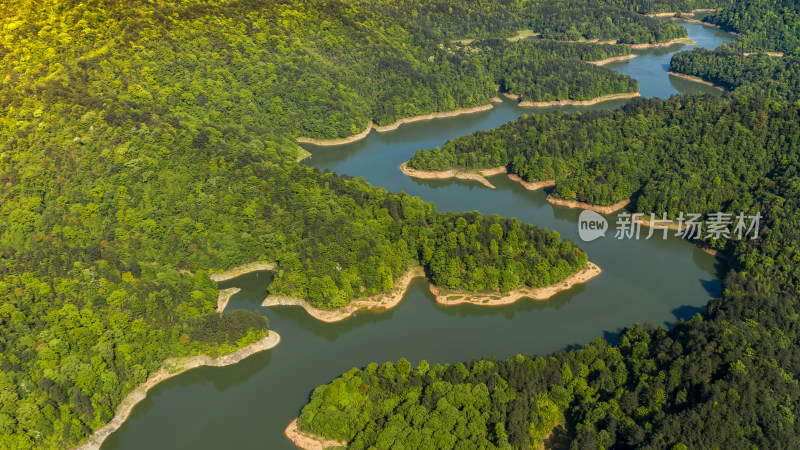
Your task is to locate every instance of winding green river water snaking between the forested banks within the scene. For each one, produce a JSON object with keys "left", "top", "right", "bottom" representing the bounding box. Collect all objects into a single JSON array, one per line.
[{"left": 103, "top": 23, "right": 733, "bottom": 449}]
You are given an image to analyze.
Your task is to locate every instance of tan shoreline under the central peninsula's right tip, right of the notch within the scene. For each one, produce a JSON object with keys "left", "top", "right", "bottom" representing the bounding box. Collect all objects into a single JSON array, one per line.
[{"left": 430, "top": 262, "right": 603, "bottom": 306}]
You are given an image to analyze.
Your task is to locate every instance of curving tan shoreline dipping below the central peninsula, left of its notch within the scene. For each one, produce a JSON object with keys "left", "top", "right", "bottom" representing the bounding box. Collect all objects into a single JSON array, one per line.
[{"left": 261, "top": 264, "right": 425, "bottom": 323}]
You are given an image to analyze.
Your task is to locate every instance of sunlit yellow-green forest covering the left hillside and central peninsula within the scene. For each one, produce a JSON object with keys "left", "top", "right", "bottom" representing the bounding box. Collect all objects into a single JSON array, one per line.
[{"left": 0, "top": 0, "right": 700, "bottom": 448}]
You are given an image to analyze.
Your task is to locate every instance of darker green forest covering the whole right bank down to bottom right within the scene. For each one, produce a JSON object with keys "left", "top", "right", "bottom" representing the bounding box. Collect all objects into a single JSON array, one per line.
[{"left": 300, "top": 2, "right": 800, "bottom": 449}]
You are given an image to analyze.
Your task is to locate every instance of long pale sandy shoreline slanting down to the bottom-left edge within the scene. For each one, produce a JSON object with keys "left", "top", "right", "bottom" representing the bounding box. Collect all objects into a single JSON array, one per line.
[{"left": 74, "top": 330, "right": 281, "bottom": 450}]
